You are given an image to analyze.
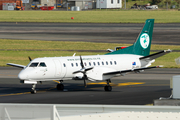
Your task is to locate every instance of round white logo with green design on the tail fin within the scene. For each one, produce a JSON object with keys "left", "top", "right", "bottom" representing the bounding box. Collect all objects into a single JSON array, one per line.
[{"left": 140, "top": 33, "right": 149, "bottom": 49}]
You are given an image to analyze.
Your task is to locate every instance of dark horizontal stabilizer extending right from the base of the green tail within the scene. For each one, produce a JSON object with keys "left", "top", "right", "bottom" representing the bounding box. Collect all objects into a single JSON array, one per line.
[{"left": 139, "top": 50, "right": 172, "bottom": 60}]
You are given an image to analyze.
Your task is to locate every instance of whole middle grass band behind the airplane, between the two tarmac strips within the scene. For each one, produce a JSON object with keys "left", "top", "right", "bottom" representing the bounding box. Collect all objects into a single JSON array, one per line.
[{"left": 0, "top": 39, "right": 180, "bottom": 68}]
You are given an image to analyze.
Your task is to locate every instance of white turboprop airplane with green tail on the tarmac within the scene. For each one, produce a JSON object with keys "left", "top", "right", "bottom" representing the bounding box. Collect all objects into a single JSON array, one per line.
[{"left": 7, "top": 19, "right": 171, "bottom": 93}]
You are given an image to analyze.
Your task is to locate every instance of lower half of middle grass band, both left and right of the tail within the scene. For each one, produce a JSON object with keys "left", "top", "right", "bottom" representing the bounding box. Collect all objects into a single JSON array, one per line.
[{"left": 0, "top": 51, "right": 180, "bottom": 68}]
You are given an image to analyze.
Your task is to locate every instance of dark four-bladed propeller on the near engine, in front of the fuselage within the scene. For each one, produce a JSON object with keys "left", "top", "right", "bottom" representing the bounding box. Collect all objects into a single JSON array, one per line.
[{"left": 73, "top": 55, "right": 93, "bottom": 87}]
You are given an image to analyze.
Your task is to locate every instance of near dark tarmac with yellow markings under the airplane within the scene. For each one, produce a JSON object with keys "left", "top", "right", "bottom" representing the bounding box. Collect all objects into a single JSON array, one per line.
[{"left": 0, "top": 67, "right": 180, "bottom": 105}]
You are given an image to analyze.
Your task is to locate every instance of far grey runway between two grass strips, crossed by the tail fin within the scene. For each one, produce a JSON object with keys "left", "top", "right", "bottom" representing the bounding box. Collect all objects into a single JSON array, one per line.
[{"left": 0, "top": 23, "right": 180, "bottom": 45}]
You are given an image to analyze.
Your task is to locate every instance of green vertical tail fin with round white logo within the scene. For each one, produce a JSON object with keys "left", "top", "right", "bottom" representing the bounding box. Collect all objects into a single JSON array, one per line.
[{"left": 106, "top": 19, "right": 154, "bottom": 56}]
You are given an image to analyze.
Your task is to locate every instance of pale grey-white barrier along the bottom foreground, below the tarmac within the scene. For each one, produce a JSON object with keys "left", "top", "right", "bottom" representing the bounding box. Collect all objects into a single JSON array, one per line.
[{"left": 0, "top": 104, "right": 180, "bottom": 120}]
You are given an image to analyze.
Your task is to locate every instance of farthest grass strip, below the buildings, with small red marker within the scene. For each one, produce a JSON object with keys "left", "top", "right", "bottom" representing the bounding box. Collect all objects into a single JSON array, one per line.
[{"left": 0, "top": 10, "right": 180, "bottom": 23}]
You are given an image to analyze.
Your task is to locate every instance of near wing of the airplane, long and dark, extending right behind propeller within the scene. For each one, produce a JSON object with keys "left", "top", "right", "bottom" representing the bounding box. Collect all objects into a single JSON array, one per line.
[{"left": 103, "top": 66, "right": 163, "bottom": 75}]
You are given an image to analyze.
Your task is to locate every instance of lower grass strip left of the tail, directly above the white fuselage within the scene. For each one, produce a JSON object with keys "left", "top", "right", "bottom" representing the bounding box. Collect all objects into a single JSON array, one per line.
[{"left": 0, "top": 51, "right": 105, "bottom": 66}]
